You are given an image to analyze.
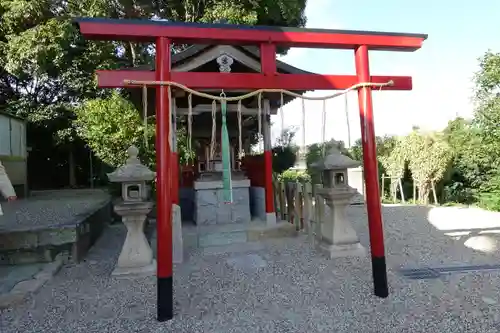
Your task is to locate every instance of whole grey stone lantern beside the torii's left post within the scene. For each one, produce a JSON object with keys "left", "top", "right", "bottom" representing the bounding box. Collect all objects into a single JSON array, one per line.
[{"left": 108, "top": 146, "right": 156, "bottom": 277}]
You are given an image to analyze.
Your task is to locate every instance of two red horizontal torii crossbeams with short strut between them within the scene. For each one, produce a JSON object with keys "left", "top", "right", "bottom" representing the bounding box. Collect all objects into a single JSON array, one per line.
[{"left": 76, "top": 18, "right": 427, "bottom": 90}]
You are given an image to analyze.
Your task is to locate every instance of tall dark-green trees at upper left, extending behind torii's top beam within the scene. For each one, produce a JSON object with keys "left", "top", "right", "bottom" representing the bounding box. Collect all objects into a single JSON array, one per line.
[{"left": 0, "top": 0, "right": 306, "bottom": 187}]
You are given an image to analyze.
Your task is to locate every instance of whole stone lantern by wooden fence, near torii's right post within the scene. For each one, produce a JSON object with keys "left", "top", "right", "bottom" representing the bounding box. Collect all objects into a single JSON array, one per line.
[{"left": 312, "top": 148, "right": 365, "bottom": 258}]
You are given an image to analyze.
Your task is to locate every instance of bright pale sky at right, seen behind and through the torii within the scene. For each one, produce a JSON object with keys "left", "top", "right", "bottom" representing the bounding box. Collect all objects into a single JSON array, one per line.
[{"left": 272, "top": 0, "right": 500, "bottom": 144}]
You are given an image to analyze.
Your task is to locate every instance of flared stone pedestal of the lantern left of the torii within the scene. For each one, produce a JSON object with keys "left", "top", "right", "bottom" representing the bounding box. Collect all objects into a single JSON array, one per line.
[{"left": 112, "top": 202, "right": 156, "bottom": 277}]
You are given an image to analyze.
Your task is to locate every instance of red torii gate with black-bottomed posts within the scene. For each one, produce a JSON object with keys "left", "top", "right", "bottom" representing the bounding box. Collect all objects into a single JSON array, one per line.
[{"left": 75, "top": 18, "right": 427, "bottom": 321}]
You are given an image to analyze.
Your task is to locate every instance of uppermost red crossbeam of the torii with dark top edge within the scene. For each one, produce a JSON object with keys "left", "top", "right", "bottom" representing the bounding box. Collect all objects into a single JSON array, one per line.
[{"left": 74, "top": 18, "right": 427, "bottom": 51}]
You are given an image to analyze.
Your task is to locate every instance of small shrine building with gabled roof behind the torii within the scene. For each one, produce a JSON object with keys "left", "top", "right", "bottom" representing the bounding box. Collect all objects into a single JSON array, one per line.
[{"left": 130, "top": 45, "right": 311, "bottom": 225}]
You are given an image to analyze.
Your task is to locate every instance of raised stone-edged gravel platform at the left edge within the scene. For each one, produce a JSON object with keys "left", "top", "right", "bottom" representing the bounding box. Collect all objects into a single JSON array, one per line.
[{"left": 0, "top": 195, "right": 111, "bottom": 265}]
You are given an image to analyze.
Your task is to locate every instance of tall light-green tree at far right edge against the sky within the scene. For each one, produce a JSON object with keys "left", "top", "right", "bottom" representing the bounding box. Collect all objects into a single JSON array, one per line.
[{"left": 448, "top": 51, "right": 500, "bottom": 210}]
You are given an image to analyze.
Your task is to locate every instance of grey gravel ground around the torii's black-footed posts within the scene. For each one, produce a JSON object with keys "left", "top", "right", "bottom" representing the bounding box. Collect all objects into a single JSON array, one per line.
[{"left": 0, "top": 206, "right": 500, "bottom": 333}]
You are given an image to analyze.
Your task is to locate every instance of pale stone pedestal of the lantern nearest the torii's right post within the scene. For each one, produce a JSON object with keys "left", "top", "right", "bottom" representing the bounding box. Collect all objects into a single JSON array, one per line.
[{"left": 318, "top": 186, "right": 366, "bottom": 258}]
